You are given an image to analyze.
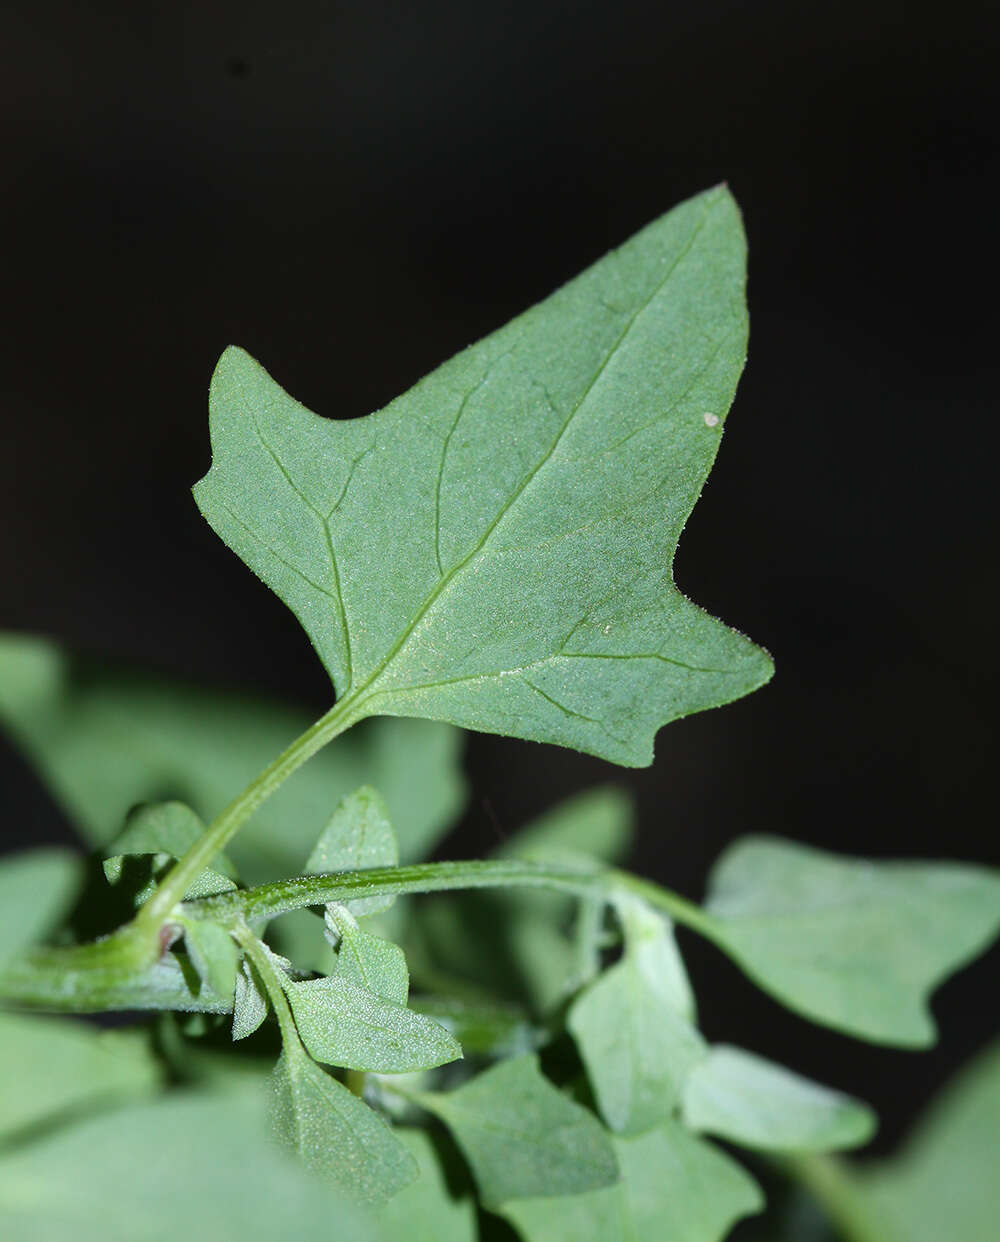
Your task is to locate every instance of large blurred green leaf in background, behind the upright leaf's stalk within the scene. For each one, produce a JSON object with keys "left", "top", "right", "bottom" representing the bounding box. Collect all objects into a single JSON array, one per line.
[{"left": 0, "top": 635, "right": 465, "bottom": 884}]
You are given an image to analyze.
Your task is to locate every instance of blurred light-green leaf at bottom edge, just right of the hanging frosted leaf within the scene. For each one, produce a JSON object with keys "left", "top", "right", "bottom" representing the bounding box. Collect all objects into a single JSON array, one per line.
[{"left": 378, "top": 1126, "right": 480, "bottom": 1242}]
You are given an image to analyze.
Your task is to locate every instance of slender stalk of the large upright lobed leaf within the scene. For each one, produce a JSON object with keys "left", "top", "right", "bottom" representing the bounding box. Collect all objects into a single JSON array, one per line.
[{"left": 135, "top": 698, "right": 360, "bottom": 933}]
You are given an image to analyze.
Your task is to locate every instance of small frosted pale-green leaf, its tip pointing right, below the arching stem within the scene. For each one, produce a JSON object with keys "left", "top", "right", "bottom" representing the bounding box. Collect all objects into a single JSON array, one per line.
[{"left": 284, "top": 975, "right": 462, "bottom": 1074}]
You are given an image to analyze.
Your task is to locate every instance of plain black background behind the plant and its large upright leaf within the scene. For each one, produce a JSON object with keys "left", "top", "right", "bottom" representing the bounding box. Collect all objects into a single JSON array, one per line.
[{"left": 0, "top": 0, "right": 1000, "bottom": 1141}]
